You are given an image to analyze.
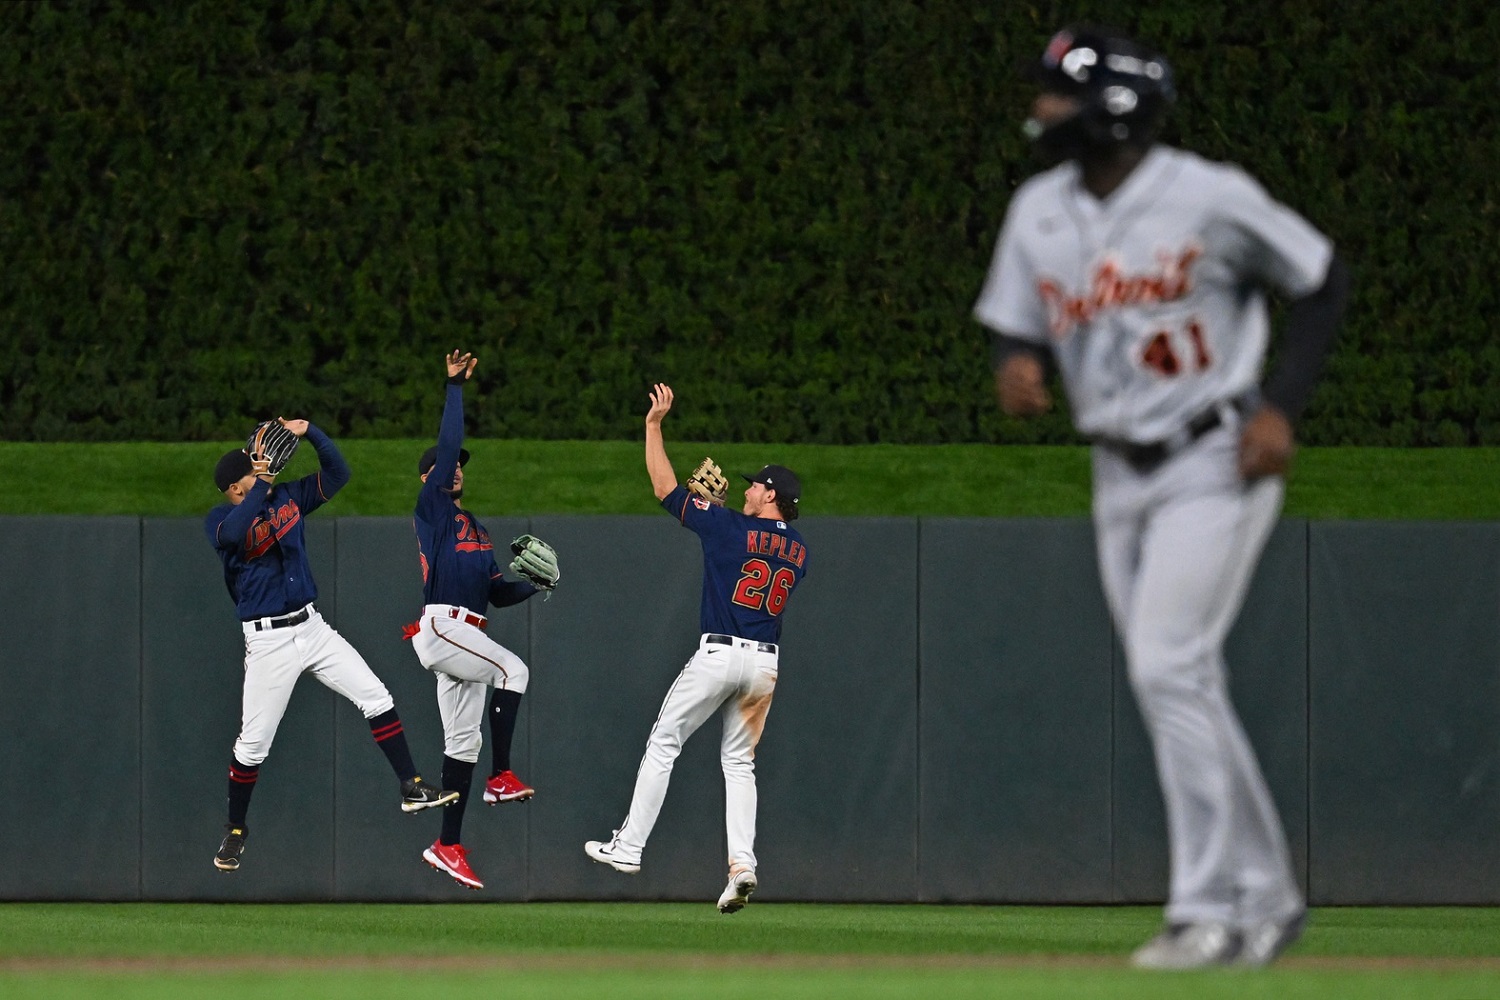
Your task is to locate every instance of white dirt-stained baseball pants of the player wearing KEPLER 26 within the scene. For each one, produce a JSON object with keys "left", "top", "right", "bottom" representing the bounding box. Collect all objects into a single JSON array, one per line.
[{"left": 614, "top": 636, "right": 777, "bottom": 871}]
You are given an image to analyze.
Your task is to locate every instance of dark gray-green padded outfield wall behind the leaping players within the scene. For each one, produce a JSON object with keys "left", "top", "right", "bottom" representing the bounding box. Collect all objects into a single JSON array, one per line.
[{"left": 0, "top": 516, "right": 1500, "bottom": 904}]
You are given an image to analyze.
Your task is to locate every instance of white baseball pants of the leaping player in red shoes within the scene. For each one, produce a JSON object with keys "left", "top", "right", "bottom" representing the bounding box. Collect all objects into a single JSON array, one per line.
[{"left": 411, "top": 604, "right": 531, "bottom": 763}]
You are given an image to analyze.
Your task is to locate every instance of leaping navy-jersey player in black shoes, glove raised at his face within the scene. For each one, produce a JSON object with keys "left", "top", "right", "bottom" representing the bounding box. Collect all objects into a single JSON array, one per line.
[{"left": 204, "top": 420, "right": 458, "bottom": 871}]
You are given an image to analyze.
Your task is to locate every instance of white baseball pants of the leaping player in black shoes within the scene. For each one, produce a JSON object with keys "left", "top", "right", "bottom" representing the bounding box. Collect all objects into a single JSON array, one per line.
[{"left": 234, "top": 604, "right": 396, "bottom": 766}]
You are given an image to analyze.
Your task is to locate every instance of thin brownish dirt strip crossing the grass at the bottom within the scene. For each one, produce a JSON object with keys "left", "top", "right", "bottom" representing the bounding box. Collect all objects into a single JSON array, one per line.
[{"left": 0, "top": 952, "right": 1500, "bottom": 975}]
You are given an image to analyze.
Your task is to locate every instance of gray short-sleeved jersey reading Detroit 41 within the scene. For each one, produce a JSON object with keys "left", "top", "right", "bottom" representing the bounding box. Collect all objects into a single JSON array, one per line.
[{"left": 974, "top": 145, "right": 1332, "bottom": 442}]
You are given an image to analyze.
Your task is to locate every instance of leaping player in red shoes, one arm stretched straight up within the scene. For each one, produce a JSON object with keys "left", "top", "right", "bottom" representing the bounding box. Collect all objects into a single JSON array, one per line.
[{"left": 407, "top": 351, "right": 558, "bottom": 889}]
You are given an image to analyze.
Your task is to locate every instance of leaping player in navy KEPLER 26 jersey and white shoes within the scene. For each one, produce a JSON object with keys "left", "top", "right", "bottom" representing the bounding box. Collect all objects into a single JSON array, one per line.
[{"left": 584, "top": 384, "right": 807, "bottom": 913}]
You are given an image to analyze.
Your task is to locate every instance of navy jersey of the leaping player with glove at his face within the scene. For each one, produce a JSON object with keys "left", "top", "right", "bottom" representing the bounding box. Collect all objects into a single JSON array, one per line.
[{"left": 203, "top": 424, "right": 350, "bottom": 621}]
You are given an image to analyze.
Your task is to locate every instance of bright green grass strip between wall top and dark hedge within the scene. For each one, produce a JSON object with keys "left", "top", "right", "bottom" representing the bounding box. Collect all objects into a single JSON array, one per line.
[{"left": 0, "top": 439, "right": 1500, "bottom": 520}]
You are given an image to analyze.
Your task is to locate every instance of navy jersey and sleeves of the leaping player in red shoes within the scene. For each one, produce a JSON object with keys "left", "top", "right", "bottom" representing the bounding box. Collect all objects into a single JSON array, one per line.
[{"left": 413, "top": 385, "right": 537, "bottom": 615}]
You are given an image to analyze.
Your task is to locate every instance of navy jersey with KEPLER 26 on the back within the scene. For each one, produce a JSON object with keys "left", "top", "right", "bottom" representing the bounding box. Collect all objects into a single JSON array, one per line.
[{"left": 662, "top": 486, "right": 807, "bottom": 642}]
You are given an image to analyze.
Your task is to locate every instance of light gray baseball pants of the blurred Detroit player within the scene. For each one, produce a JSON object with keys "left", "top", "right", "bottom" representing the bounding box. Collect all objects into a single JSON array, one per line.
[{"left": 1094, "top": 424, "right": 1302, "bottom": 927}]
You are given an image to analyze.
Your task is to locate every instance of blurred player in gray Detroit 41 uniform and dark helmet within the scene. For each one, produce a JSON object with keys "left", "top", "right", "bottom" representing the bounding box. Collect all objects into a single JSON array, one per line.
[{"left": 975, "top": 28, "right": 1349, "bottom": 969}]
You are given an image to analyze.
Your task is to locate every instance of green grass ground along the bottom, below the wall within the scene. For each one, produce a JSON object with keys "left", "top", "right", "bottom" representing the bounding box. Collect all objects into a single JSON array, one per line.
[{"left": 0, "top": 903, "right": 1500, "bottom": 1000}]
